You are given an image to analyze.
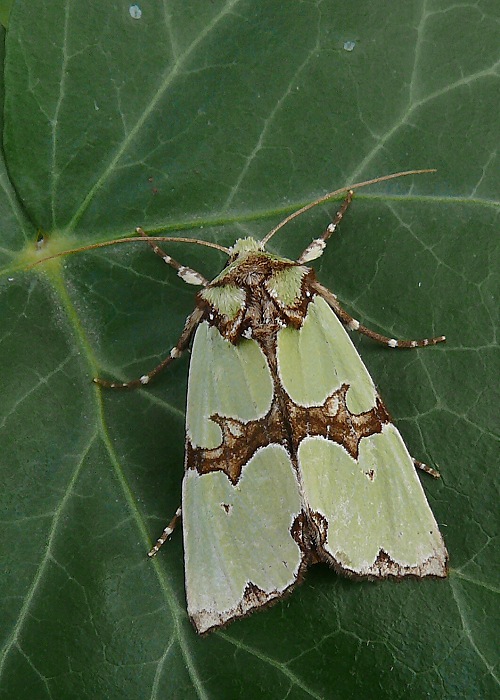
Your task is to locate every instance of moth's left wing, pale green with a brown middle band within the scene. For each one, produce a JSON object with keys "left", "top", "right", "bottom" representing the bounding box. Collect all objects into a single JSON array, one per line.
[{"left": 182, "top": 322, "right": 303, "bottom": 633}]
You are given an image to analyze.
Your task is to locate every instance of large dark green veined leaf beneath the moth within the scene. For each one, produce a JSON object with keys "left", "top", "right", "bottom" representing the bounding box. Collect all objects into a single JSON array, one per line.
[{"left": 0, "top": 0, "right": 499, "bottom": 700}]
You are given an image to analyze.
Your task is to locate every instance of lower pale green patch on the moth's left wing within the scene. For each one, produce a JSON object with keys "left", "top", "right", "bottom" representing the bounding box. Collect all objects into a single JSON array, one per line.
[{"left": 182, "top": 445, "right": 302, "bottom": 633}]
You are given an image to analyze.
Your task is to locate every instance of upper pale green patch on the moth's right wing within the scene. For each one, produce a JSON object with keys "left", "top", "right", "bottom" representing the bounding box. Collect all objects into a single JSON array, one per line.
[{"left": 277, "top": 296, "right": 377, "bottom": 413}]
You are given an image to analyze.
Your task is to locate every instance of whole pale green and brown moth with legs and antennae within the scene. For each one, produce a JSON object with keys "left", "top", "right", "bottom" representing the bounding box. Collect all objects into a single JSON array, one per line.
[{"left": 36, "top": 171, "right": 448, "bottom": 634}]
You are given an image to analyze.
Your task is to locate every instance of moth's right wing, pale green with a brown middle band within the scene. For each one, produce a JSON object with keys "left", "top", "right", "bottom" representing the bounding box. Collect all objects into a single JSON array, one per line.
[{"left": 277, "top": 296, "right": 447, "bottom": 577}]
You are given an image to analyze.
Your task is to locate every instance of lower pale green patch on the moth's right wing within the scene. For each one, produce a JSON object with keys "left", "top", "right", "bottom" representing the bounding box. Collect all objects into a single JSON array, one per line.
[{"left": 299, "top": 424, "right": 447, "bottom": 577}]
